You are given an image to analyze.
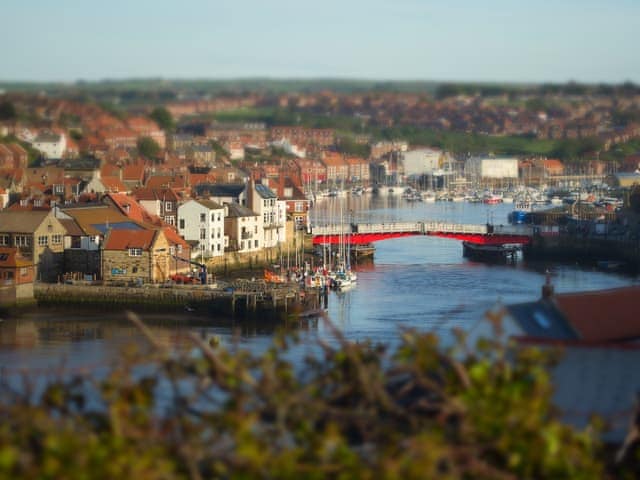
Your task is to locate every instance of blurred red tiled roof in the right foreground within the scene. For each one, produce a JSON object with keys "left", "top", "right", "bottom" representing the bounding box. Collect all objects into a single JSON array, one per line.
[{"left": 554, "top": 286, "right": 640, "bottom": 342}]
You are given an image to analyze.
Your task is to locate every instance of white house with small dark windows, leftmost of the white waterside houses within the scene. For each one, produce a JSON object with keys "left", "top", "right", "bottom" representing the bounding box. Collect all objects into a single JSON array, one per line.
[{"left": 178, "top": 200, "right": 225, "bottom": 257}]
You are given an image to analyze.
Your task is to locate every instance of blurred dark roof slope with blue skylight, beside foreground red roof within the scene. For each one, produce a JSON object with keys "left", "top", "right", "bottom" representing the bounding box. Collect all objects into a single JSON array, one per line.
[{"left": 506, "top": 300, "right": 579, "bottom": 340}]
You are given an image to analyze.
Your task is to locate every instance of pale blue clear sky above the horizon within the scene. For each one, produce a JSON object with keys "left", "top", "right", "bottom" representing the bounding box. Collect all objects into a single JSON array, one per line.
[{"left": 0, "top": 0, "right": 640, "bottom": 83}]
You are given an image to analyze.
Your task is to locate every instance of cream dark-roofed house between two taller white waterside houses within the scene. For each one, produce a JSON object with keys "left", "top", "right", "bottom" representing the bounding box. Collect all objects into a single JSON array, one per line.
[{"left": 224, "top": 203, "right": 264, "bottom": 253}]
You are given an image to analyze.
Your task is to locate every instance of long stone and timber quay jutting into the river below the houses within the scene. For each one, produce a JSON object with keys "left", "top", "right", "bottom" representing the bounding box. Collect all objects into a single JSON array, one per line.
[{"left": 34, "top": 280, "right": 326, "bottom": 320}]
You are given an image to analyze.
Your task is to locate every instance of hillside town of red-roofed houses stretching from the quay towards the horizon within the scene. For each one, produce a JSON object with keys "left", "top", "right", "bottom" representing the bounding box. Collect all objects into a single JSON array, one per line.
[{"left": 0, "top": 85, "right": 640, "bottom": 298}]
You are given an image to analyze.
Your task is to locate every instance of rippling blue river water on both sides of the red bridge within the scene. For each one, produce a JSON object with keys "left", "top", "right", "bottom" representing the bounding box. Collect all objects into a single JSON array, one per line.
[{"left": 0, "top": 196, "right": 638, "bottom": 374}]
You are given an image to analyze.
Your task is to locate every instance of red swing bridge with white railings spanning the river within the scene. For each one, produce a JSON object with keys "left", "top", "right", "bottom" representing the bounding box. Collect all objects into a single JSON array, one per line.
[{"left": 311, "top": 221, "right": 534, "bottom": 246}]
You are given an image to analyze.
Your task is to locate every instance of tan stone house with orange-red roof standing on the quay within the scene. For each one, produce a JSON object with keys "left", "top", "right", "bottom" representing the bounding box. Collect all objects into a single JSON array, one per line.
[{"left": 102, "top": 230, "right": 170, "bottom": 283}]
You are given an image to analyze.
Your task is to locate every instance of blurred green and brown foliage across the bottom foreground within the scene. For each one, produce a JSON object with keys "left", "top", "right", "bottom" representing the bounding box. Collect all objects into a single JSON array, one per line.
[{"left": 0, "top": 317, "right": 628, "bottom": 479}]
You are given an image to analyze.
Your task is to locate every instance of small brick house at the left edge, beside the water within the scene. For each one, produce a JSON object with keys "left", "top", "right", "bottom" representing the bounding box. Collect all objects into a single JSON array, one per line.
[{"left": 0, "top": 247, "right": 35, "bottom": 305}]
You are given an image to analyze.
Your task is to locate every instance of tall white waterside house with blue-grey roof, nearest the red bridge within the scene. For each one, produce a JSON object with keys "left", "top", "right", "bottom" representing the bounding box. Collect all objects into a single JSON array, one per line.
[{"left": 247, "top": 180, "right": 287, "bottom": 248}]
